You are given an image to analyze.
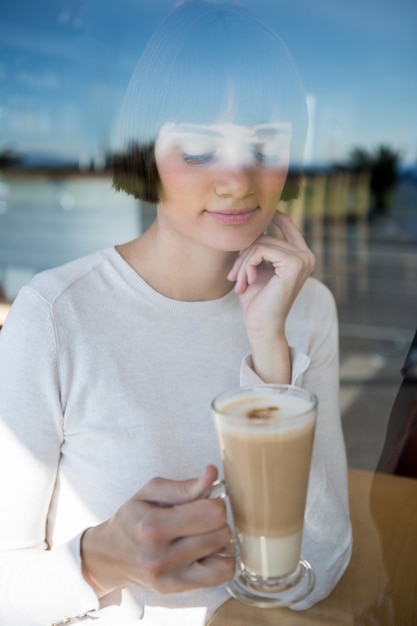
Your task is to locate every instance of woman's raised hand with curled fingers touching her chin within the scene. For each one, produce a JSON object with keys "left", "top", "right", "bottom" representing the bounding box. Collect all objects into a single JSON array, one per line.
[{"left": 228, "top": 211, "right": 315, "bottom": 382}]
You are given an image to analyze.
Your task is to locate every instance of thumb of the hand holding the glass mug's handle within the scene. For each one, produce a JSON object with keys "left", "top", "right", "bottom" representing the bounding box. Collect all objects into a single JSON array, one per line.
[{"left": 139, "top": 465, "right": 218, "bottom": 506}]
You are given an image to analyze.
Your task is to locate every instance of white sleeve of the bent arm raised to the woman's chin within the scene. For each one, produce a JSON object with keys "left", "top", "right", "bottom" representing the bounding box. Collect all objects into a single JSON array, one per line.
[{"left": 237, "top": 281, "right": 352, "bottom": 610}]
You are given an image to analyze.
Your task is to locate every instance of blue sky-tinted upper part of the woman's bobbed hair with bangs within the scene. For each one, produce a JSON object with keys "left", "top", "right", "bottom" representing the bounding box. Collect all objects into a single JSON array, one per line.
[{"left": 118, "top": 2, "right": 307, "bottom": 163}]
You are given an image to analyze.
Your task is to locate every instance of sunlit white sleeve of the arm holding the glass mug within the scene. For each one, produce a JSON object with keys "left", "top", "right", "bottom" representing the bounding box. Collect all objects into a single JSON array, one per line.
[{"left": 0, "top": 287, "right": 98, "bottom": 626}]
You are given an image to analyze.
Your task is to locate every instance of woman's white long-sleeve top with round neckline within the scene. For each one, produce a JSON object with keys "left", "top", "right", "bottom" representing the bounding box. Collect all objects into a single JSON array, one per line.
[{"left": 0, "top": 248, "right": 351, "bottom": 626}]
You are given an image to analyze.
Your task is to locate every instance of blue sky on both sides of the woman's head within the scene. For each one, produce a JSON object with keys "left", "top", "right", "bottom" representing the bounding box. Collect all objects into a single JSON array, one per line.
[{"left": 0, "top": 0, "right": 417, "bottom": 163}]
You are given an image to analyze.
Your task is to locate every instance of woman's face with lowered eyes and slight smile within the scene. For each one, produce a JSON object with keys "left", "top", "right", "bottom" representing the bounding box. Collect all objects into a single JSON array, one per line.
[{"left": 155, "top": 123, "right": 291, "bottom": 251}]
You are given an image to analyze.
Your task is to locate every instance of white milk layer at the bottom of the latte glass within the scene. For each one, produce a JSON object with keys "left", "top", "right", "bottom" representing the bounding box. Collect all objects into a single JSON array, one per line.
[{"left": 239, "top": 532, "right": 302, "bottom": 578}]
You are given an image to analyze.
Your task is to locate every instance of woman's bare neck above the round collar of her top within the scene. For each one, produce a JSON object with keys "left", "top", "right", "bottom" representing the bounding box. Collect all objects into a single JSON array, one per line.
[{"left": 117, "top": 222, "right": 238, "bottom": 302}]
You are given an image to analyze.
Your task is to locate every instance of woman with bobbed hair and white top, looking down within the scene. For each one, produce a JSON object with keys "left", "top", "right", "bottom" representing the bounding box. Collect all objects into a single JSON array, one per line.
[{"left": 0, "top": 1, "right": 351, "bottom": 626}]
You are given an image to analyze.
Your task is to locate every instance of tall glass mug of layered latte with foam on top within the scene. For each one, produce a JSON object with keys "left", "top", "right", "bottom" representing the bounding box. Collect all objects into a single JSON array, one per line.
[{"left": 212, "top": 385, "right": 317, "bottom": 607}]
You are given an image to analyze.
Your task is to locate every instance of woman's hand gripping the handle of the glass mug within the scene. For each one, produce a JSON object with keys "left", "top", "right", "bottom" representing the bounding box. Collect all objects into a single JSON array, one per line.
[{"left": 81, "top": 465, "right": 235, "bottom": 598}]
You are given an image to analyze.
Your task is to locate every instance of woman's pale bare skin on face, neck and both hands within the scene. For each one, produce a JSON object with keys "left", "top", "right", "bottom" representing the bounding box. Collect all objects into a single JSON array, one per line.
[{"left": 81, "top": 124, "right": 314, "bottom": 598}]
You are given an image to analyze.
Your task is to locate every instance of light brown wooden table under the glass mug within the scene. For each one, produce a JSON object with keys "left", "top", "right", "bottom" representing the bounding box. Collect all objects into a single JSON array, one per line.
[{"left": 210, "top": 469, "right": 417, "bottom": 626}]
